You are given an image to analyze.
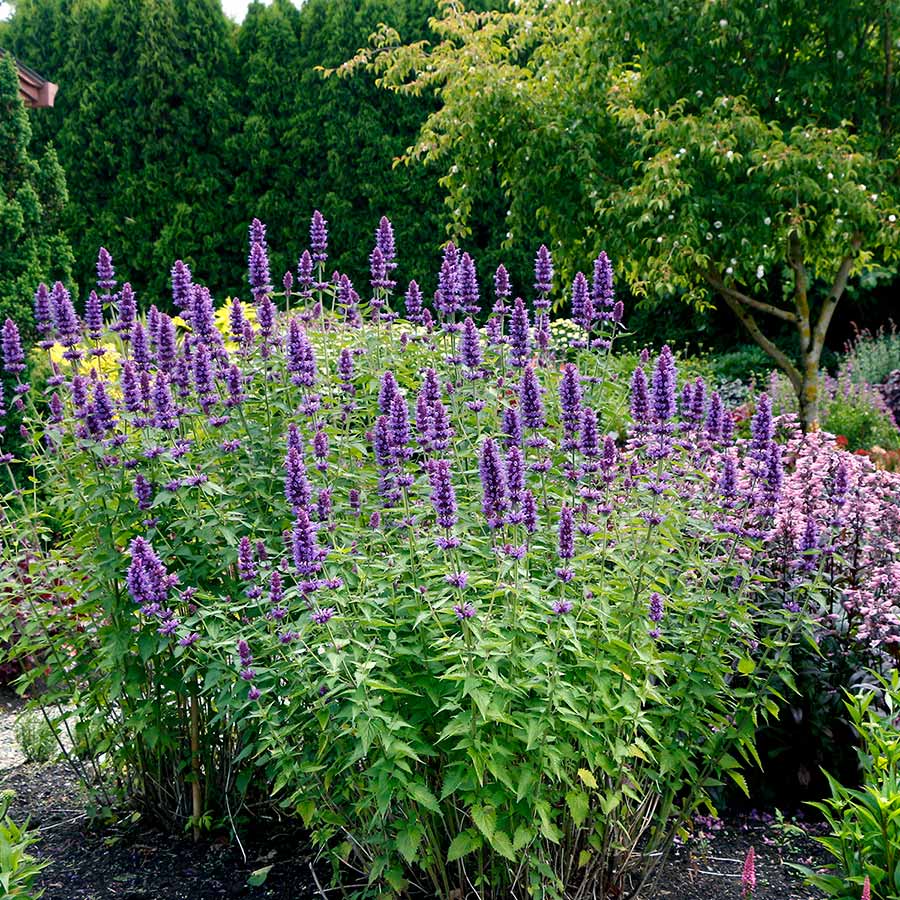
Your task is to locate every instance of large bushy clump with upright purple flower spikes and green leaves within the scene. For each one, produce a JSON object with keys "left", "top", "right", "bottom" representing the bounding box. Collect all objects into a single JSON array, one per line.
[{"left": 3, "top": 220, "right": 880, "bottom": 898}]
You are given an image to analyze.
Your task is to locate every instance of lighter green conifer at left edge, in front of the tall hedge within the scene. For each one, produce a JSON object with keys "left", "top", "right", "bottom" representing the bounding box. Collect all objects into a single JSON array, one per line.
[{"left": 0, "top": 54, "right": 72, "bottom": 330}]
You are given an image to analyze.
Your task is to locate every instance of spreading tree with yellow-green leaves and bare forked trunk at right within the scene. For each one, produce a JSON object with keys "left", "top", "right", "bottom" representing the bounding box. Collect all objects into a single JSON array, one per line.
[{"left": 343, "top": 0, "right": 900, "bottom": 424}]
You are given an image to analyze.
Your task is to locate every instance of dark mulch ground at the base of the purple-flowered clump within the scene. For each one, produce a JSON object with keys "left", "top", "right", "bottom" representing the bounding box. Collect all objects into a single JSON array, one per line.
[{"left": 0, "top": 765, "right": 822, "bottom": 900}]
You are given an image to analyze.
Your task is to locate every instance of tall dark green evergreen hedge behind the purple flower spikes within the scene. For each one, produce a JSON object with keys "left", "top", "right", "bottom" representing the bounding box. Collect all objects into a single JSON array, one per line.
[{"left": 4, "top": 0, "right": 464, "bottom": 310}]
